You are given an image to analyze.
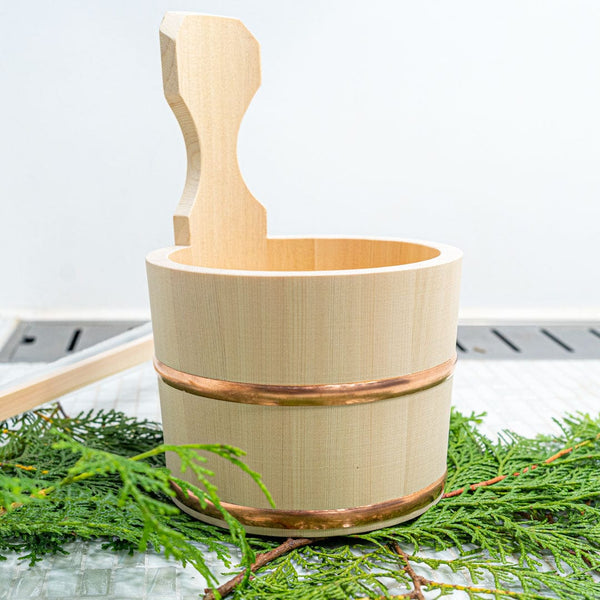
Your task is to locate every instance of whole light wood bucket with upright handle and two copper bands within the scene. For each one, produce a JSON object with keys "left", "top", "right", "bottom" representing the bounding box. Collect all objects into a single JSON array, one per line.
[{"left": 146, "top": 13, "right": 462, "bottom": 537}]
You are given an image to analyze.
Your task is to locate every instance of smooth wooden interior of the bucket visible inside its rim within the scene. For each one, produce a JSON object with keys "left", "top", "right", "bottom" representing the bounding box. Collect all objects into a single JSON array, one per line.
[{"left": 170, "top": 238, "right": 440, "bottom": 271}]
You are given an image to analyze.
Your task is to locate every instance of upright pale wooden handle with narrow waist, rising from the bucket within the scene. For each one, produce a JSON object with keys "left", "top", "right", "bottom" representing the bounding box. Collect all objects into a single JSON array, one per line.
[{"left": 160, "top": 12, "right": 266, "bottom": 268}]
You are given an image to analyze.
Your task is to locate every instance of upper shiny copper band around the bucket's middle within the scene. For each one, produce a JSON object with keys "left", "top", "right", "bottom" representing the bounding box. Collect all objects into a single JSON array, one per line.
[{"left": 154, "top": 355, "right": 456, "bottom": 406}]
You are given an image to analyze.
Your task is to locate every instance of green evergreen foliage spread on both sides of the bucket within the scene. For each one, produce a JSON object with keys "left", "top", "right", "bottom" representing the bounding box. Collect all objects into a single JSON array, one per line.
[{"left": 0, "top": 409, "right": 600, "bottom": 600}]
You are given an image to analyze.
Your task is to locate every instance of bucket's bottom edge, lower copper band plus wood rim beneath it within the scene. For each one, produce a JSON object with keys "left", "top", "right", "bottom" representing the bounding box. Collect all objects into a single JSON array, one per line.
[{"left": 173, "top": 473, "right": 446, "bottom": 538}]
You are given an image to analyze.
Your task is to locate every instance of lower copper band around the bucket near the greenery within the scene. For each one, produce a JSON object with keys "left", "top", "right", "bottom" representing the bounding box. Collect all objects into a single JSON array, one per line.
[{"left": 170, "top": 473, "right": 446, "bottom": 530}]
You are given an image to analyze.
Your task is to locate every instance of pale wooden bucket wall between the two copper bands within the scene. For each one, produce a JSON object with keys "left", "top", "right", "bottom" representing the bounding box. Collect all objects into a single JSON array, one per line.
[{"left": 159, "top": 380, "right": 452, "bottom": 510}]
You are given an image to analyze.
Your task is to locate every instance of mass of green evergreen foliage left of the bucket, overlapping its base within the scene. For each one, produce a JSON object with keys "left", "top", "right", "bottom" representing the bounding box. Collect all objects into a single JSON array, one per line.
[{"left": 0, "top": 409, "right": 274, "bottom": 583}]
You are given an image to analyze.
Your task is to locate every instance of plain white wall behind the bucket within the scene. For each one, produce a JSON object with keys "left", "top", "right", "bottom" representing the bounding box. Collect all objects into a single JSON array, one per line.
[{"left": 0, "top": 0, "right": 600, "bottom": 314}]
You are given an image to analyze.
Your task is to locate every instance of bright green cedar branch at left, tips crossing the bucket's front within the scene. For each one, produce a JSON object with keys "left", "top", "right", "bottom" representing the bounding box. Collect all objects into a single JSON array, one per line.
[{"left": 0, "top": 411, "right": 272, "bottom": 584}]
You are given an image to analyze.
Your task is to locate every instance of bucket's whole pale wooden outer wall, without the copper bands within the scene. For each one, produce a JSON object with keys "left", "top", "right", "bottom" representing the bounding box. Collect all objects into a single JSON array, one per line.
[{"left": 147, "top": 240, "right": 461, "bottom": 536}]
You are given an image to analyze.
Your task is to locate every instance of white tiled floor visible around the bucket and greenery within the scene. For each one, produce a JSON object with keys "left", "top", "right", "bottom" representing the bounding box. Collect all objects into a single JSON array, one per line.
[{"left": 0, "top": 350, "right": 600, "bottom": 600}]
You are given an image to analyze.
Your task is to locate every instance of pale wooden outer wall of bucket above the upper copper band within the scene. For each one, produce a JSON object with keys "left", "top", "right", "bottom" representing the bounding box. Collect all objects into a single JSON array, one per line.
[{"left": 147, "top": 240, "right": 460, "bottom": 385}]
